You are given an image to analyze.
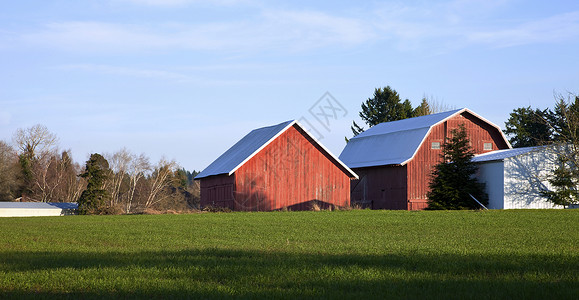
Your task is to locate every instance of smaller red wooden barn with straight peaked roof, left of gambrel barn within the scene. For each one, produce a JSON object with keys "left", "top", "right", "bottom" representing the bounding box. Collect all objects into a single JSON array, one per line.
[{"left": 195, "top": 121, "right": 358, "bottom": 211}]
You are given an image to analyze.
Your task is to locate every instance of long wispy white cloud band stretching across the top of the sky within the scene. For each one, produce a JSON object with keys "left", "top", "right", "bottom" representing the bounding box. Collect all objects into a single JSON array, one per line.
[{"left": 13, "top": 0, "right": 579, "bottom": 55}]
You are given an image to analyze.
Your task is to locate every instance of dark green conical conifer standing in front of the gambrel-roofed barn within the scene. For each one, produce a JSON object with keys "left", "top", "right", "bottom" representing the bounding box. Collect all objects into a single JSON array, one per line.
[{"left": 427, "top": 125, "right": 488, "bottom": 210}]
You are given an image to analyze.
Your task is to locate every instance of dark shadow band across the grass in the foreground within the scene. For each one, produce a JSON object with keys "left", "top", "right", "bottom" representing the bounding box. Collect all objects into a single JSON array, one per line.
[{"left": 0, "top": 249, "right": 579, "bottom": 299}]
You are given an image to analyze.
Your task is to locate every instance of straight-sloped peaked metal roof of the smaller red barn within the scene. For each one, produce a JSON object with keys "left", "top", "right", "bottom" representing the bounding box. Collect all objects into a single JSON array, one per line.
[{"left": 195, "top": 120, "right": 358, "bottom": 179}]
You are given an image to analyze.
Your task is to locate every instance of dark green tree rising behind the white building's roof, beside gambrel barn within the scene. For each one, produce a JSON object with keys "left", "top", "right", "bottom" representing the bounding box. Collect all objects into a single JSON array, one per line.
[{"left": 503, "top": 106, "right": 553, "bottom": 148}]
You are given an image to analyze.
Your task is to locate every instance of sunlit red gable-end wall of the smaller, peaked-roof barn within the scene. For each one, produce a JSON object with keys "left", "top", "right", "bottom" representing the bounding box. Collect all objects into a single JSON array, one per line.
[{"left": 235, "top": 125, "right": 350, "bottom": 211}]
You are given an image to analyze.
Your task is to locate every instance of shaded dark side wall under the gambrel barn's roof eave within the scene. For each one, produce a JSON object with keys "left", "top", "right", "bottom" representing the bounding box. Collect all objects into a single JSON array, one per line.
[{"left": 351, "top": 166, "right": 407, "bottom": 209}]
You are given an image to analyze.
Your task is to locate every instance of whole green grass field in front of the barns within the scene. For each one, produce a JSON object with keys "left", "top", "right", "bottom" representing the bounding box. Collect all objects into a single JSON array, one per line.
[{"left": 0, "top": 210, "right": 579, "bottom": 299}]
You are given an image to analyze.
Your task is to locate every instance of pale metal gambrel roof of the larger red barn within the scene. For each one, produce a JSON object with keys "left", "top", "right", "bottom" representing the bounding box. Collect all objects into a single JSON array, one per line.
[{"left": 340, "top": 108, "right": 509, "bottom": 168}]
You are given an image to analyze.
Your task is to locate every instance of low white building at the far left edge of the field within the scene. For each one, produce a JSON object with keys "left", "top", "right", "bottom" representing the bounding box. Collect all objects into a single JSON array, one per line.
[{"left": 0, "top": 202, "right": 78, "bottom": 217}]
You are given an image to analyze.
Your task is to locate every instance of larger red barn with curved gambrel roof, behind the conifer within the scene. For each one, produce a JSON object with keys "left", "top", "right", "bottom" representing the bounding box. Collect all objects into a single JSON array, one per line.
[{"left": 340, "top": 108, "right": 511, "bottom": 210}]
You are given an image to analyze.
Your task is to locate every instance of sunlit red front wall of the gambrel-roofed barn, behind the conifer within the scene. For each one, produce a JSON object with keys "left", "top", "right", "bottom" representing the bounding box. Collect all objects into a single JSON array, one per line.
[{"left": 407, "top": 112, "right": 508, "bottom": 210}]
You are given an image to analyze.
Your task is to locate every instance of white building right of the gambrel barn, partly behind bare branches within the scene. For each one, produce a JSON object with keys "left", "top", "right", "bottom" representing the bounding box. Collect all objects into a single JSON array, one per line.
[{"left": 473, "top": 147, "right": 563, "bottom": 209}]
